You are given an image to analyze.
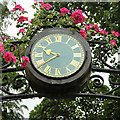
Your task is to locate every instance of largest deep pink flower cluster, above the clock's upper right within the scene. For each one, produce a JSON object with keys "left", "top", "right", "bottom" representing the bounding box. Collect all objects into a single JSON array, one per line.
[{"left": 71, "top": 9, "right": 85, "bottom": 24}]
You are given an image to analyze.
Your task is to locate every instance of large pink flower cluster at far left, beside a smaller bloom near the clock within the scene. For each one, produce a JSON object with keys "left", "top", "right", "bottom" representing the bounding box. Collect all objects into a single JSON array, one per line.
[{"left": 3, "top": 51, "right": 17, "bottom": 63}]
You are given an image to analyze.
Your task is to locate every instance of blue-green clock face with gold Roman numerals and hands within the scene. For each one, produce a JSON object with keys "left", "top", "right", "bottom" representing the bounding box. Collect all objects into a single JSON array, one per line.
[{"left": 31, "top": 34, "right": 85, "bottom": 78}]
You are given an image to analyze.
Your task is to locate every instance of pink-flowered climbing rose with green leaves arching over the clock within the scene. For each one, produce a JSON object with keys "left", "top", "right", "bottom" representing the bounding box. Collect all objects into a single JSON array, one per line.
[{"left": 0, "top": 0, "right": 120, "bottom": 67}]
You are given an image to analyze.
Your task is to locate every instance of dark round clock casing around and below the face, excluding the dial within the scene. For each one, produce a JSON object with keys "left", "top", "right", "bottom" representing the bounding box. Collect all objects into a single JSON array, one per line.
[{"left": 25, "top": 28, "right": 91, "bottom": 98}]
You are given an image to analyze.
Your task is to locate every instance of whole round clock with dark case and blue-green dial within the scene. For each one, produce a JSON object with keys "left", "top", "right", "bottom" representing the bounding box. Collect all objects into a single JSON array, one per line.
[{"left": 26, "top": 28, "right": 91, "bottom": 96}]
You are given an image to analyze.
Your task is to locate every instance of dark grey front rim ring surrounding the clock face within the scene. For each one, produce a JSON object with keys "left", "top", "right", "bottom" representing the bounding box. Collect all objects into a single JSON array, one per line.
[{"left": 26, "top": 28, "right": 91, "bottom": 84}]
